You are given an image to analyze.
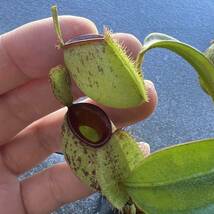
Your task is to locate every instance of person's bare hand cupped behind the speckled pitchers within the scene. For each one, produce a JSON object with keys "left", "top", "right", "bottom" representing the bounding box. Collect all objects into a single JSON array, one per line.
[{"left": 0, "top": 16, "right": 157, "bottom": 214}]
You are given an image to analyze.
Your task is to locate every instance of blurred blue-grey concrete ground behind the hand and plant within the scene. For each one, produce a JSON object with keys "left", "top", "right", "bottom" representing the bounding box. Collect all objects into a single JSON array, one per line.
[{"left": 0, "top": 0, "right": 214, "bottom": 214}]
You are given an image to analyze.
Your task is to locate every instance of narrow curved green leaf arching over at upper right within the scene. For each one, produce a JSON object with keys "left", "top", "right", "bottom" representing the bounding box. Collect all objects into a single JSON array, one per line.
[{"left": 137, "top": 33, "right": 214, "bottom": 100}]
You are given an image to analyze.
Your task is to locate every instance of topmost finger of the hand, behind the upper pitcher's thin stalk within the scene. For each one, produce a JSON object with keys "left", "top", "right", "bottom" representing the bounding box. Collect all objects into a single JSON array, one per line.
[{"left": 0, "top": 16, "right": 97, "bottom": 95}]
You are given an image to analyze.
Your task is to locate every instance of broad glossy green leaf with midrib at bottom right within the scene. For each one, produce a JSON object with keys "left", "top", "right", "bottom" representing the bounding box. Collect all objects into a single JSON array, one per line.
[{"left": 124, "top": 139, "right": 214, "bottom": 214}]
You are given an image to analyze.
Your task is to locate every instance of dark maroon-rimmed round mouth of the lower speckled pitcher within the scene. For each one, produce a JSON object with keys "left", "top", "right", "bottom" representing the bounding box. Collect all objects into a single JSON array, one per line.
[{"left": 67, "top": 103, "right": 112, "bottom": 148}]
